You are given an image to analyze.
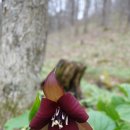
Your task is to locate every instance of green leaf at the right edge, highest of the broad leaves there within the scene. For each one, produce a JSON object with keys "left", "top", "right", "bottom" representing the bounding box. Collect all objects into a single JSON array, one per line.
[{"left": 119, "top": 84, "right": 130, "bottom": 100}]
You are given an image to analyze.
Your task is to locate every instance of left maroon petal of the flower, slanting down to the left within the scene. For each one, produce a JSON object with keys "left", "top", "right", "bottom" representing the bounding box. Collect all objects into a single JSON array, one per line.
[{"left": 29, "top": 98, "right": 57, "bottom": 130}]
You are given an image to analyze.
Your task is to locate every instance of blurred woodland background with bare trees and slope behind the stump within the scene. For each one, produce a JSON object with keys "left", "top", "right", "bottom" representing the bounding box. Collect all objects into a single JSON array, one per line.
[{"left": 45, "top": 0, "right": 130, "bottom": 84}]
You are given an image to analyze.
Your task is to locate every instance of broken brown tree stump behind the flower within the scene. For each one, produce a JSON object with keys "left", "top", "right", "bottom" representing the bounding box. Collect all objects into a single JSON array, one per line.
[{"left": 55, "top": 59, "right": 86, "bottom": 99}]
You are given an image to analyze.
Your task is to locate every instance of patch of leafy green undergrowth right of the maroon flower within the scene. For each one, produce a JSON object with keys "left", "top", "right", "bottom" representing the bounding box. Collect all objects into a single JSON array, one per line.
[{"left": 81, "top": 82, "right": 130, "bottom": 130}]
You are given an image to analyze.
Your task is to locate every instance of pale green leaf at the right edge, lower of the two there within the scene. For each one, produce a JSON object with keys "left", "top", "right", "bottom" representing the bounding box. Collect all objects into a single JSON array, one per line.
[{"left": 116, "top": 104, "right": 130, "bottom": 123}]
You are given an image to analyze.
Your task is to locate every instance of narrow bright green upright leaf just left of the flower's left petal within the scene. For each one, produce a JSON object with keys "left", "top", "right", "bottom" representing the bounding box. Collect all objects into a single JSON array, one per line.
[{"left": 29, "top": 91, "right": 43, "bottom": 121}]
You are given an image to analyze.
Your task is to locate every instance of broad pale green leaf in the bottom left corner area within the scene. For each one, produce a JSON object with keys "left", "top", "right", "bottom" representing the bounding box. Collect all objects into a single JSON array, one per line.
[{"left": 4, "top": 111, "right": 29, "bottom": 130}]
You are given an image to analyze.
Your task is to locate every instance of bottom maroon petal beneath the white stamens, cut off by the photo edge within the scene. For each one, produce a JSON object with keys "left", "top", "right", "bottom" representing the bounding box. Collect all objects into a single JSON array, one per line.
[{"left": 48, "top": 121, "right": 79, "bottom": 130}]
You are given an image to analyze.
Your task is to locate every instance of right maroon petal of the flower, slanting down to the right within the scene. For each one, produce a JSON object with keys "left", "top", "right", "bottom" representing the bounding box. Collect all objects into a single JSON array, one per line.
[{"left": 58, "top": 93, "right": 88, "bottom": 123}]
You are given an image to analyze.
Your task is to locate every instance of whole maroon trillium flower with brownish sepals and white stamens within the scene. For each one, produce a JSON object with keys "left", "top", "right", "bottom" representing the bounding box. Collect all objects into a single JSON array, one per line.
[{"left": 30, "top": 71, "right": 92, "bottom": 130}]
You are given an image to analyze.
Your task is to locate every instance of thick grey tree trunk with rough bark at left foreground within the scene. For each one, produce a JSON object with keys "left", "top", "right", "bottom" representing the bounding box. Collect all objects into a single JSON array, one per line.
[{"left": 0, "top": 0, "right": 48, "bottom": 119}]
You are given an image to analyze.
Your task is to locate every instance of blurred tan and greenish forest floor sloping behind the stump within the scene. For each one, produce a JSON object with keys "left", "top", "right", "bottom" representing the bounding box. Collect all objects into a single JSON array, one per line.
[{"left": 42, "top": 24, "right": 130, "bottom": 87}]
